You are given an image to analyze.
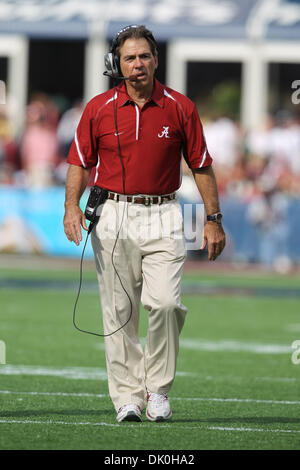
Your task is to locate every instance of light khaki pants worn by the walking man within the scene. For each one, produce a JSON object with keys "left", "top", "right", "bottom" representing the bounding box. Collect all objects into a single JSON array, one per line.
[{"left": 92, "top": 200, "right": 187, "bottom": 411}]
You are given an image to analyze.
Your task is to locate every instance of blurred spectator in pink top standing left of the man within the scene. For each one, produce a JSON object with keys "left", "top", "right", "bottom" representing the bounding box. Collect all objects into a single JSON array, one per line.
[{"left": 20, "top": 97, "right": 59, "bottom": 188}]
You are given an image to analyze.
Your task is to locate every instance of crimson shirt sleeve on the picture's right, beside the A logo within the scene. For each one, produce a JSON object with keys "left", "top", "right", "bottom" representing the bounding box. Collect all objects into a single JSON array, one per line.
[{"left": 183, "top": 106, "right": 212, "bottom": 169}]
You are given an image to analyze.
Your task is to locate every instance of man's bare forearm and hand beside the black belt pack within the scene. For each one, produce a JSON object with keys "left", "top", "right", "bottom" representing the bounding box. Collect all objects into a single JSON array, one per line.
[{"left": 64, "top": 165, "right": 91, "bottom": 245}]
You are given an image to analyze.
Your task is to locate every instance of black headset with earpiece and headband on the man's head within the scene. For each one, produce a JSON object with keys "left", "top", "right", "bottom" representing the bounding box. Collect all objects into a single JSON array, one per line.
[{"left": 103, "top": 24, "right": 158, "bottom": 80}]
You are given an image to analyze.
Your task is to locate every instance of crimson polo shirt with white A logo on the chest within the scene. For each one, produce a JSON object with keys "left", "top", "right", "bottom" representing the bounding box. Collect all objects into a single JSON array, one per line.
[{"left": 67, "top": 79, "right": 212, "bottom": 195}]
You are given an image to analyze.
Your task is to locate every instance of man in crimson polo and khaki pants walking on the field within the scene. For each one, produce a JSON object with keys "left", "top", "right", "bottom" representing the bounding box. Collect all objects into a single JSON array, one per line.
[{"left": 64, "top": 26, "right": 225, "bottom": 422}]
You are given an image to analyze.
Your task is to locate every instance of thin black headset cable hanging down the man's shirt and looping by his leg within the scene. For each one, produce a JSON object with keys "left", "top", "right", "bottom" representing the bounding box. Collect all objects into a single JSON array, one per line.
[{"left": 73, "top": 81, "right": 132, "bottom": 338}]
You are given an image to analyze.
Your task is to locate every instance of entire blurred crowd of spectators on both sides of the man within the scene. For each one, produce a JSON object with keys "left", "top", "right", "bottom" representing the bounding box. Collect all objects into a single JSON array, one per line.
[{"left": 0, "top": 94, "right": 300, "bottom": 202}]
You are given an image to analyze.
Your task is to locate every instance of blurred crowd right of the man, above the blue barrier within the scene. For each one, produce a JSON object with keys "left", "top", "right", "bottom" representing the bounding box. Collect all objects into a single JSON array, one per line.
[{"left": 204, "top": 111, "right": 300, "bottom": 201}]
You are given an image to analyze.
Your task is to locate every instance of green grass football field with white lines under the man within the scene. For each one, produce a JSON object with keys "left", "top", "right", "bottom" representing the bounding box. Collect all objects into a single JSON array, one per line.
[{"left": 0, "top": 266, "right": 300, "bottom": 450}]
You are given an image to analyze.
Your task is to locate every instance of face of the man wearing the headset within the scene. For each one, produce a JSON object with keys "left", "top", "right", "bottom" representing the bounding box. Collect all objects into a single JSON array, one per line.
[{"left": 120, "top": 38, "right": 158, "bottom": 87}]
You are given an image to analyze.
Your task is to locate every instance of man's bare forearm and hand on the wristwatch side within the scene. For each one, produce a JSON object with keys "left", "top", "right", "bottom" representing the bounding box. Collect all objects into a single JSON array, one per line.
[{"left": 192, "top": 166, "right": 226, "bottom": 261}]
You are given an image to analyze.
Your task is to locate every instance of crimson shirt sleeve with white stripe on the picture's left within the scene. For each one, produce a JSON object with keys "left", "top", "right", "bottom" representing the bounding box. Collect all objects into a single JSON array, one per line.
[{"left": 67, "top": 103, "right": 98, "bottom": 168}]
